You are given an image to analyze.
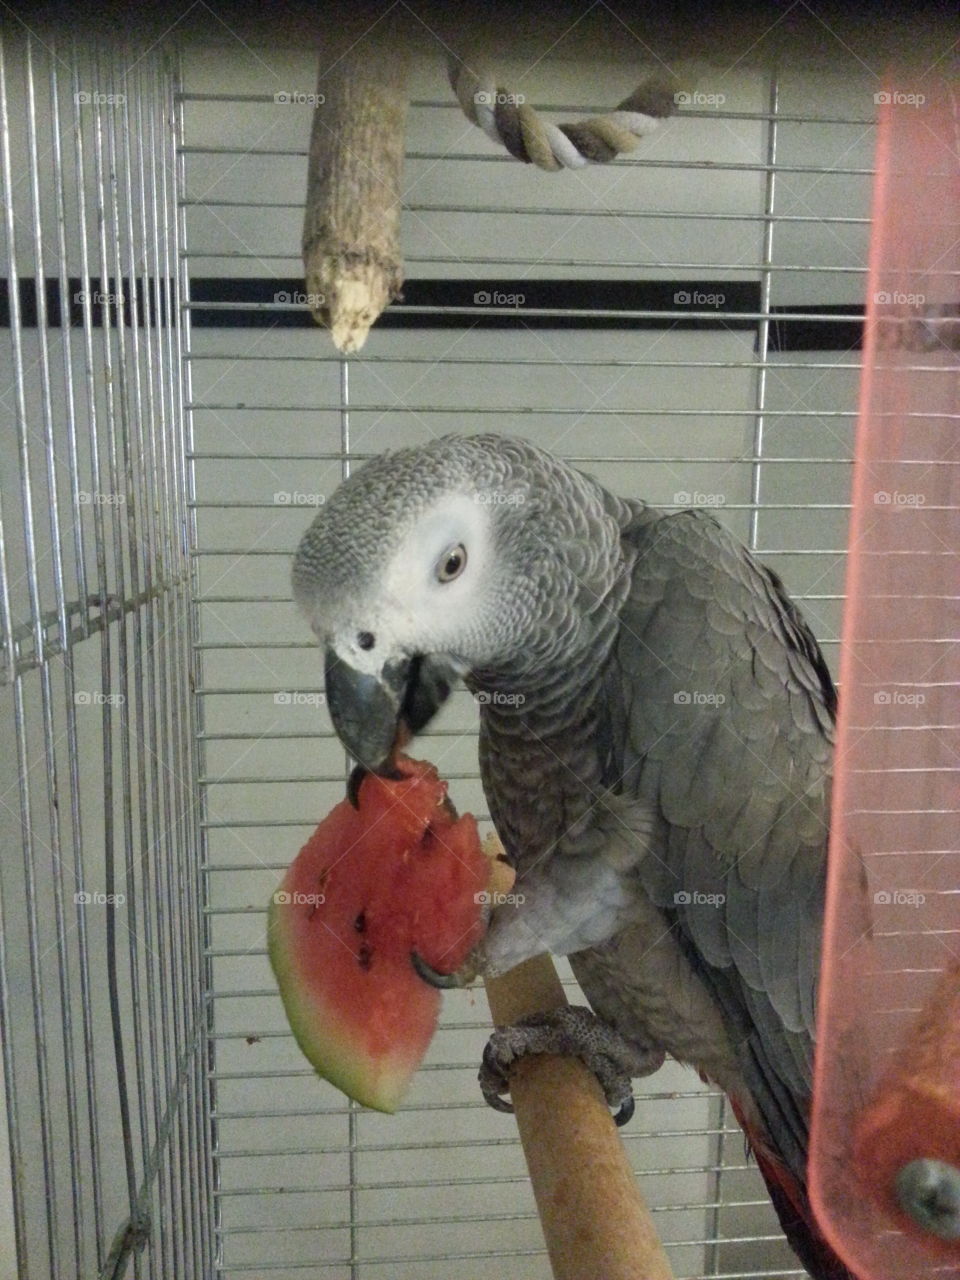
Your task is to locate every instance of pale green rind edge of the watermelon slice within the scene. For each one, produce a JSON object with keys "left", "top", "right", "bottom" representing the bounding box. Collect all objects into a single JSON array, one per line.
[{"left": 266, "top": 899, "right": 430, "bottom": 1115}]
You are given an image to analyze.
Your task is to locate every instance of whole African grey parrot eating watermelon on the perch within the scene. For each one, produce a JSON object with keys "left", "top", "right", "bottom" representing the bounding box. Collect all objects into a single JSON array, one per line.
[{"left": 293, "top": 434, "right": 850, "bottom": 1280}]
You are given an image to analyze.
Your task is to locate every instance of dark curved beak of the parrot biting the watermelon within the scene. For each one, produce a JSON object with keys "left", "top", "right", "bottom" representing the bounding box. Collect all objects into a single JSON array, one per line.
[{"left": 324, "top": 649, "right": 451, "bottom": 808}]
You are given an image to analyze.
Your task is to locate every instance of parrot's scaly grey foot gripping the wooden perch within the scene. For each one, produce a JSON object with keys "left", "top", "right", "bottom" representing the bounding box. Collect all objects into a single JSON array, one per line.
[{"left": 479, "top": 1005, "right": 666, "bottom": 1125}]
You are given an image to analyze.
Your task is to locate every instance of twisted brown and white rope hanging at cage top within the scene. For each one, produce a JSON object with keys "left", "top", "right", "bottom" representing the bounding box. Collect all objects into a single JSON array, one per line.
[{"left": 448, "top": 56, "right": 676, "bottom": 172}]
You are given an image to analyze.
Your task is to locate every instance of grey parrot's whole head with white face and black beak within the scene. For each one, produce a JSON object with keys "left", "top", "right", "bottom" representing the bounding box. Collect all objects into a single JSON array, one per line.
[{"left": 293, "top": 435, "right": 624, "bottom": 773}]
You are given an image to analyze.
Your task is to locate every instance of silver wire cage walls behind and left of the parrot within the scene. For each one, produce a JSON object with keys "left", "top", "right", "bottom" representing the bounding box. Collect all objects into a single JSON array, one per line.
[{"left": 0, "top": 17, "right": 896, "bottom": 1280}]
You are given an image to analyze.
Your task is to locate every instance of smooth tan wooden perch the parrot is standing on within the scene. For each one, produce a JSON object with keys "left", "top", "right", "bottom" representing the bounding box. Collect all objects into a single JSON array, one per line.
[{"left": 486, "top": 844, "right": 673, "bottom": 1280}]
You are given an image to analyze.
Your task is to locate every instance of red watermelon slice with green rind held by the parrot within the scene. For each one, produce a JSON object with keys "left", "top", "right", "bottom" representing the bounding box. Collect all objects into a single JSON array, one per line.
[{"left": 268, "top": 756, "right": 490, "bottom": 1111}]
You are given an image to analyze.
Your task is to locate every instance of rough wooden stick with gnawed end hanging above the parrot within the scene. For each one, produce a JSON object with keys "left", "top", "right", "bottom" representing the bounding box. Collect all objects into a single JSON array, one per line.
[{"left": 303, "top": 28, "right": 407, "bottom": 352}]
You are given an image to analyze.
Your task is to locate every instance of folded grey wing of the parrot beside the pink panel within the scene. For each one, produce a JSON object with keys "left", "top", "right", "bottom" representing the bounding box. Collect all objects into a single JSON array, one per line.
[{"left": 602, "top": 509, "right": 836, "bottom": 1187}]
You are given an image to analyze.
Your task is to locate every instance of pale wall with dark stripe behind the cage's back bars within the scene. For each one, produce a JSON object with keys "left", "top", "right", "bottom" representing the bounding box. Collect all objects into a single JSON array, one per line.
[{"left": 176, "top": 40, "right": 874, "bottom": 1280}]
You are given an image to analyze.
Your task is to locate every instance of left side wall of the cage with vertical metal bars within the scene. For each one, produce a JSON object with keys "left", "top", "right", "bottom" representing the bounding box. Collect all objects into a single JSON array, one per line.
[{"left": 0, "top": 36, "right": 212, "bottom": 1280}]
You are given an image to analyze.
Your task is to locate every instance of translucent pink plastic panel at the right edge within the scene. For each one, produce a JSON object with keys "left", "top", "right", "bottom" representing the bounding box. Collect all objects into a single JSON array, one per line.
[{"left": 810, "top": 77, "right": 960, "bottom": 1280}]
